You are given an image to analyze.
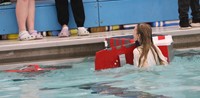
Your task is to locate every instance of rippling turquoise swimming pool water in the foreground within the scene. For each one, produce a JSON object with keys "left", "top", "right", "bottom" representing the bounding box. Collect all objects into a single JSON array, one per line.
[{"left": 0, "top": 51, "right": 200, "bottom": 98}]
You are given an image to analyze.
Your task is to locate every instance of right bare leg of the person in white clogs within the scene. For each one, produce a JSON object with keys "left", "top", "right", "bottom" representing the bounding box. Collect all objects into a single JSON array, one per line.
[{"left": 27, "top": 0, "right": 35, "bottom": 32}]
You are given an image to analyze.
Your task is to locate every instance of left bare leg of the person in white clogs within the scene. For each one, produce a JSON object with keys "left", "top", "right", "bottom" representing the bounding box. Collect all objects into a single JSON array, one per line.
[{"left": 16, "top": 0, "right": 29, "bottom": 32}]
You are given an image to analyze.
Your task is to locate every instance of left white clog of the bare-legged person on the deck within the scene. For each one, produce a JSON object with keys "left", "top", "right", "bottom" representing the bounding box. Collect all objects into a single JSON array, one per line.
[{"left": 18, "top": 31, "right": 35, "bottom": 41}]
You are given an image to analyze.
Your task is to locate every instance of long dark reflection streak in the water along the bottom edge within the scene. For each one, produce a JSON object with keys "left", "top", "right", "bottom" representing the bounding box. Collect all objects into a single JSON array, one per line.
[{"left": 40, "top": 81, "right": 171, "bottom": 98}]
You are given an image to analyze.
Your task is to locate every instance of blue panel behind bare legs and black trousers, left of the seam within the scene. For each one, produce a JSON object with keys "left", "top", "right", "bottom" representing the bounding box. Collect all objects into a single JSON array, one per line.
[{"left": 0, "top": 0, "right": 99, "bottom": 35}]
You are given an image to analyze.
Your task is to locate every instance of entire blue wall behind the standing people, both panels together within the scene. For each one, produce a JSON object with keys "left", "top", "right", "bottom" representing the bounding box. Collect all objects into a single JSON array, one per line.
[{"left": 0, "top": 0, "right": 178, "bottom": 35}]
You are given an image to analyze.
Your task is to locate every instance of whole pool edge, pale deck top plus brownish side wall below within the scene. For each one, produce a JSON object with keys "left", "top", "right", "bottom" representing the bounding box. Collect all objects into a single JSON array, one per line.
[{"left": 0, "top": 26, "right": 200, "bottom": 65}]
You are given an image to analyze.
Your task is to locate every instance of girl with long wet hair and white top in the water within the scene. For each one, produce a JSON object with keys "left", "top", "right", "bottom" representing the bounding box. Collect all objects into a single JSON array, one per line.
[{"left": 133, "top": 24, "right": 168, "bottom": 68}]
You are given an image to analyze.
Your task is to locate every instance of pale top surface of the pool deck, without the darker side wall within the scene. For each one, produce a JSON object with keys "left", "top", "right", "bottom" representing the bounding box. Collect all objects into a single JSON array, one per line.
[{"left": 0, "top": 26, "right": 200, "bottom": 51}]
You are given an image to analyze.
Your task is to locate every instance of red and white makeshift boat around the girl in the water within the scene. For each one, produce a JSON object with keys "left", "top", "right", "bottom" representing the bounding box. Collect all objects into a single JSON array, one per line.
[{"left": 95, "top": 35, "right": 173, "bottom": 70}]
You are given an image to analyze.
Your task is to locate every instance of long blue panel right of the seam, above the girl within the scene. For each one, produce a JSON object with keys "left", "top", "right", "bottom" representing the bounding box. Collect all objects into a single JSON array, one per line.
[{"left": 99, "top": 0, "right": 178, "bottom": 26}]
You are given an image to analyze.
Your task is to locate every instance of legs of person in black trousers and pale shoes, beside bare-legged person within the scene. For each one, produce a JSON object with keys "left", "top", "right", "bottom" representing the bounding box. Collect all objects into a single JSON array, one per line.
[{"left": 55, "top": 0, "right": 89, "bottom": 37}]
